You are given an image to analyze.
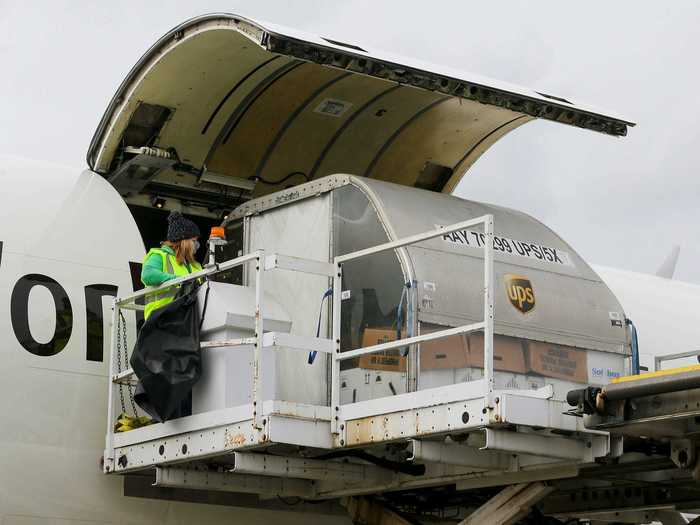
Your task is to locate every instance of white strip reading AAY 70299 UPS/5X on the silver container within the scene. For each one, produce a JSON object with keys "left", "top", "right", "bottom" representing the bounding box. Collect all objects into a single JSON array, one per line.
[{"left": 442, "top": 230, "right": 574, "bottom": 266}]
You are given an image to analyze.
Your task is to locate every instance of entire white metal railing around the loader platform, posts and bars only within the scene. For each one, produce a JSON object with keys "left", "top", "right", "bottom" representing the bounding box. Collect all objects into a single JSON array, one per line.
[{"left": 105, "top": 215, "right": 494, "bottom": 466}]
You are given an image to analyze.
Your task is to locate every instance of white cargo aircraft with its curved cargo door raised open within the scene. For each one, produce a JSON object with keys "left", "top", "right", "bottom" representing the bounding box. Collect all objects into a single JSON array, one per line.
[{"left": 0, "top": 14, "right": 700, "bottom": 525}]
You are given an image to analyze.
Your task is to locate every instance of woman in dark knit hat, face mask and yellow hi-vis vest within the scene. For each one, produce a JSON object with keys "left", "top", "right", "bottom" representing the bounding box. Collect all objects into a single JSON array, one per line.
[{"left": 141, "top": 211, "right": 202, "bottom": 319}]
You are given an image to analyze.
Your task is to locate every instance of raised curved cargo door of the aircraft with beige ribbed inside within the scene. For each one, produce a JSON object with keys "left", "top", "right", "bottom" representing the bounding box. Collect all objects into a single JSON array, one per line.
[{"left": 87, "top": 14, "right": 634, "bottom": 215}]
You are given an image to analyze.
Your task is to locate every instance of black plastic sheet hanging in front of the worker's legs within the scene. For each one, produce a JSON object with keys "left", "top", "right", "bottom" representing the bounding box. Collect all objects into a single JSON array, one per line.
[{"left": 130, "top": 282, "right": 202, "bottom": 422}]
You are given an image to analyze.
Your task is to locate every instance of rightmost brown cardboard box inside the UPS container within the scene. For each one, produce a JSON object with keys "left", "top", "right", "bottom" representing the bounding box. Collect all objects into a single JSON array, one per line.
[{"left": 528, "top": 341, "right": 588, "bottom": 383}]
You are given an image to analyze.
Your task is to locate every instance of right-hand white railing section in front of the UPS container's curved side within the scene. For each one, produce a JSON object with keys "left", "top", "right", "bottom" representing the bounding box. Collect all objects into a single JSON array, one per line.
[{"left": 331, "top": 215, "right": 494, "bottom": 434}]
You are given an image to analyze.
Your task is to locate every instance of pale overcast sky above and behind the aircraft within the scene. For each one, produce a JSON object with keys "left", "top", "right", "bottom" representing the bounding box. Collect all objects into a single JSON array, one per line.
[{"left": 0, "top": 0, "right": 700, "bottom": 282}]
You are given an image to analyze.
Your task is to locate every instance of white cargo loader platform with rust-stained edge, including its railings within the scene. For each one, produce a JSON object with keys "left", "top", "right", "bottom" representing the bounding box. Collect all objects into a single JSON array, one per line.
[{"left": 104, "top": 216, "right": 615, "bottom": 500}]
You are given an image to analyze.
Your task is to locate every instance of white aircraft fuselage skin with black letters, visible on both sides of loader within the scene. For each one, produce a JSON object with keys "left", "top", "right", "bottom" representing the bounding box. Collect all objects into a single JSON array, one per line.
[{"left": 0, "top": 157, "right": 700, "bottom": 525}]
